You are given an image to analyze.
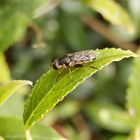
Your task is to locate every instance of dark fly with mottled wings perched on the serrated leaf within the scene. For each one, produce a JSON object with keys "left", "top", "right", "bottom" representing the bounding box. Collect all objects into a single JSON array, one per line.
[{"left": 52, "top": 50, "right": 98, "bottom": 79}]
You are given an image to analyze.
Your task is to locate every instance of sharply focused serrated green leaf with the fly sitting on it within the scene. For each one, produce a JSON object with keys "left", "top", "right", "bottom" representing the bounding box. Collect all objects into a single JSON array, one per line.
[{"left": 24, "top": 48, "right": 136, "bottom": 129}]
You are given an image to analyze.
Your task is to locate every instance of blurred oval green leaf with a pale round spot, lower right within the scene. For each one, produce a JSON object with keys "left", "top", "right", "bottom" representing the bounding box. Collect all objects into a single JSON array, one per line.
[{"left": 84, "top": 101, "right": 133, "bottom": 132}]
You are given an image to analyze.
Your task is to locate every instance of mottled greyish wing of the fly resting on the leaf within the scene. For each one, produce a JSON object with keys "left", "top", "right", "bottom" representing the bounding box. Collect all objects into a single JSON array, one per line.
[{"left": 67, "top": 50, "right": 96, "bottom": 66}]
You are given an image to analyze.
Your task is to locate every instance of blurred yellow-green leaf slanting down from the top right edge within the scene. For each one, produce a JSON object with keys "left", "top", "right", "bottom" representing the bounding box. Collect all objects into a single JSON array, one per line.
[{"left": 86, "top": 0, "right": 135, "bottom": 34}]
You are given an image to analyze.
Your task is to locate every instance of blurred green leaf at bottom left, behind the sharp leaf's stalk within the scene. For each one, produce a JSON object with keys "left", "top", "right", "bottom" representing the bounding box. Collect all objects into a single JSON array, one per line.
[{"left": 0, "top": 117, "right": 64, "bottom": 140}]
